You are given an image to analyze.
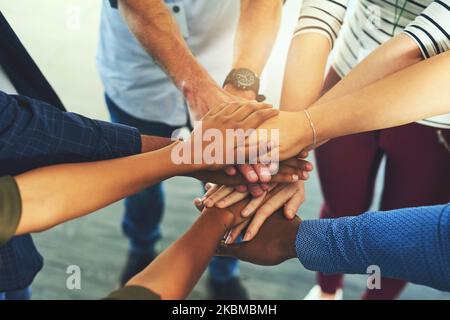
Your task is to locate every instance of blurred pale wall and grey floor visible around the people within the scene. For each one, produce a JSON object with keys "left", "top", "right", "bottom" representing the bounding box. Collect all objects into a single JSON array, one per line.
[{"left": 0, "top": 0, "right": 450, "bottom": 300}]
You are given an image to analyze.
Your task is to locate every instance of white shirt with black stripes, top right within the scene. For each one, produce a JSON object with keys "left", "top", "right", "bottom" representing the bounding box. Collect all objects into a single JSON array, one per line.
[{"left": 294, "top": 0, "right": 450, "bottom": 129}]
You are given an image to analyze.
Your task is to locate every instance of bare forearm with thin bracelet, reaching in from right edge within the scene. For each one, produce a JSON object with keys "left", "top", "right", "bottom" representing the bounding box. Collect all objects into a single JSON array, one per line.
[{"left": 308, "top": 53, "right": 450, "bottom": 141}]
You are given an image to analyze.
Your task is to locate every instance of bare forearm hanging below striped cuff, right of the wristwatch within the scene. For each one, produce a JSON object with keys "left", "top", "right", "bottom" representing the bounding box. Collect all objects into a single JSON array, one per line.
[{"left": 280, "top": 33, "right": 330, "bottom": 111}]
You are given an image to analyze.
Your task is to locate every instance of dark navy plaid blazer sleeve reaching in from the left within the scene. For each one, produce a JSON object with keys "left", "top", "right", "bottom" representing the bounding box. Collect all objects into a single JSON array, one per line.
[{"left": 0, "top": 92, "right": 141, "bottom": 176}]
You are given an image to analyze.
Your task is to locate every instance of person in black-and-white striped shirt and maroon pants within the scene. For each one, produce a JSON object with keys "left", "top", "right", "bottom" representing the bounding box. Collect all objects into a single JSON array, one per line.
[{"left": 281, "top": 0, "right": 450, "bottom": 299}]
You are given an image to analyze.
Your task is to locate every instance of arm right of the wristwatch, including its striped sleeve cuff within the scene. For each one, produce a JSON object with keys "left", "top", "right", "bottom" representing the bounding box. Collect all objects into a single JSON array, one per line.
[{"left": 281, "top": 0, "right": 348, "bottom": 111}]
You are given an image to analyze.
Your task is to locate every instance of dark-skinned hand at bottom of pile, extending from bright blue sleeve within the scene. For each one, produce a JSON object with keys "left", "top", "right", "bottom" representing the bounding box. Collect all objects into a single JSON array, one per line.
[{"left": 217, "top": 210, "right": 302, "bottom": 266}]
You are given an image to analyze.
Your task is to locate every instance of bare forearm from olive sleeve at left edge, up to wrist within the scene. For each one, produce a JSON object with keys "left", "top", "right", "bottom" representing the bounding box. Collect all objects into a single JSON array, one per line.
[{"left": 16, "top": 142, "right": 189, "bottom": 235}]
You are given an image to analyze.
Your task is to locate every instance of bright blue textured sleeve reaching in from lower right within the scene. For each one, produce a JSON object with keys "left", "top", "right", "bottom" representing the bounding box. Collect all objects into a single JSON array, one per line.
[{"left": 296, "top": 204, "right": 450, "bottom": 291}]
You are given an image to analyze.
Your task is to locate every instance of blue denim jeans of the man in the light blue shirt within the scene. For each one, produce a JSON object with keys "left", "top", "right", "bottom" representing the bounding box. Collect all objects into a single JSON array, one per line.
[{"left": 105, "top": 95, "right": 239, "bottom": 281}]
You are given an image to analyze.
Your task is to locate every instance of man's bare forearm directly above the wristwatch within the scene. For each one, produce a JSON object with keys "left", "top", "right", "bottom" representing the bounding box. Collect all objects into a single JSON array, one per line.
[{"left": 233, "top": 0, "right": 283, "bottom": 75}]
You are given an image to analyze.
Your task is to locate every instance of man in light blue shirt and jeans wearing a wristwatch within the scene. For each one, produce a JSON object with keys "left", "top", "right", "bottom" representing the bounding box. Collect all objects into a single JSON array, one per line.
[{"left": 97, "top": 0, "right": 283, "bottom": 299}]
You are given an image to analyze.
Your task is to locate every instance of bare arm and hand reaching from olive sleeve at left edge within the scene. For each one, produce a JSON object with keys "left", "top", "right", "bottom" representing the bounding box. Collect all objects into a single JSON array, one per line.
[{"left": 12, "top": 104, "right": 278, "bottom": 234}]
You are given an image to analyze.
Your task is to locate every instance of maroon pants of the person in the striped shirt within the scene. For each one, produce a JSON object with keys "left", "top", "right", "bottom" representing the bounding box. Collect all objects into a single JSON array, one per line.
[{"left": 316, "top": 70, "right": 450, "bottom": 299}]
